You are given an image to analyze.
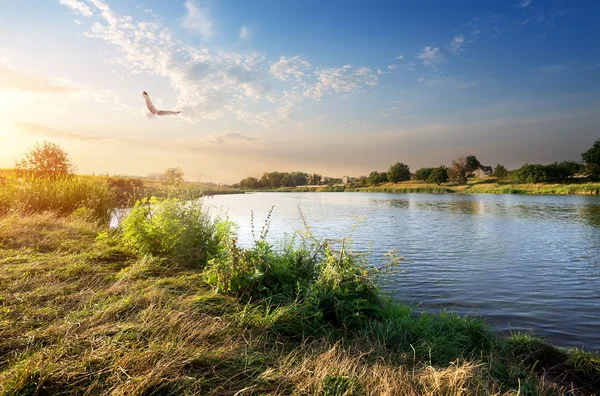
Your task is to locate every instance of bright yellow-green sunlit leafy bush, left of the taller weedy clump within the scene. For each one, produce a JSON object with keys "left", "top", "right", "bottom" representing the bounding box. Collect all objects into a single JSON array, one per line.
[{"left": 121, "top": 197, "right": 224, "bottom": 266}]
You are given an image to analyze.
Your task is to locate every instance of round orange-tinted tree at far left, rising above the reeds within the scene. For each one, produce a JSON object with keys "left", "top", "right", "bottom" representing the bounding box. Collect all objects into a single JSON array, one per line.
[{"left": 15, "top": 141, "right": 76, "bottom": 178}]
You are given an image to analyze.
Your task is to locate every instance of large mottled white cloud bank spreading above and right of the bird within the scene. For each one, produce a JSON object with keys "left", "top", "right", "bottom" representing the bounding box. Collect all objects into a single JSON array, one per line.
[{"left": 56, "top": 0, "right": 378, "bottom": 128}]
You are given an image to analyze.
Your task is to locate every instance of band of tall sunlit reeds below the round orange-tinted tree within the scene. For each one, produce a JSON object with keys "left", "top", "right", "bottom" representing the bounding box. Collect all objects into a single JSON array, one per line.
[{"left": 0, "top": 175, "right": 115, "bottom": 220}]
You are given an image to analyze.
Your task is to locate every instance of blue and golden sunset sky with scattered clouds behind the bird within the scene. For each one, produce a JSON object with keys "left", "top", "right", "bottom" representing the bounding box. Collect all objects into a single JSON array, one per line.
[{"left": 0, "top": 0, "right": 600, "bottom": 183}]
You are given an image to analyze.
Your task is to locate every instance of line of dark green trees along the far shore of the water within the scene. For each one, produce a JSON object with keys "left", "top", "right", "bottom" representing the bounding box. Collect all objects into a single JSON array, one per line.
[{"left": 233, "top": 139, "right": 600, "bottom": 189}]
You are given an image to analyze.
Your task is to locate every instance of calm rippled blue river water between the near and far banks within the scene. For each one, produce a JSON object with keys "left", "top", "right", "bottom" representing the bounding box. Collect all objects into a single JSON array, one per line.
[{"left": 206, "top": 193, "right": 600, "bottom": 350}]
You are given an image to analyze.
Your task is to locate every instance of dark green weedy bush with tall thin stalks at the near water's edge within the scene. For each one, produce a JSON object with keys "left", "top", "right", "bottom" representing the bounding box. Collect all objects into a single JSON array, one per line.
[{"left": 205, "top": 213, "right": 383, "bottom": 329}]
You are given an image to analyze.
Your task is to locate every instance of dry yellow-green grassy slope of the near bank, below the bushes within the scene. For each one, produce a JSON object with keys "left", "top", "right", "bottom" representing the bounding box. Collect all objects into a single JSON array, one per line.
[{"left": 0, "top": 214, "right": 598, "bottom": 395}]
